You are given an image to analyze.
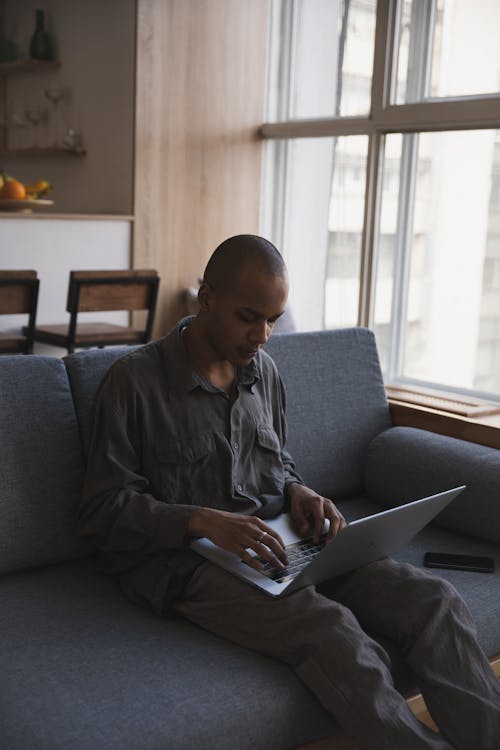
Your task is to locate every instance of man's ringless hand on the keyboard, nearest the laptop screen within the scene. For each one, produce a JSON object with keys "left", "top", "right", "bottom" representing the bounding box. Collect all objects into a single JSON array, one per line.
[{"left": 288, "top": 483, "right": 347, "bottom": 544}]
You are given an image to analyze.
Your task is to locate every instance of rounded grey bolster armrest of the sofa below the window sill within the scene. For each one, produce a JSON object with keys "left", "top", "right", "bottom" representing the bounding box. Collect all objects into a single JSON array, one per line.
[{"left": 363, "top": 427, "right": 500, "bottom": 543}]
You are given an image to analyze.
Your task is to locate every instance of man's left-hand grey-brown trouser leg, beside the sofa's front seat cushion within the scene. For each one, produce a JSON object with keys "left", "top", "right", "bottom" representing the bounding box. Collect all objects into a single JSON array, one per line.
[{"left": 176, "top": 563, "right": 451, "bottom": 750}]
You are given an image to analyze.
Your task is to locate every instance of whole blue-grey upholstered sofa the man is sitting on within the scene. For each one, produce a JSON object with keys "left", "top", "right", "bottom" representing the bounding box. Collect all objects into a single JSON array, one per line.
[{"left": 0, "top": 329, "right": 500, "bottom": 750}]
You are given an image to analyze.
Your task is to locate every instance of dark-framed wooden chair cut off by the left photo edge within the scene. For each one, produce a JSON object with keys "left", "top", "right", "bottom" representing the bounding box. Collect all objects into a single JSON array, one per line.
[{"left": 0, "top": 271, "right": 40, "bottom": 354}]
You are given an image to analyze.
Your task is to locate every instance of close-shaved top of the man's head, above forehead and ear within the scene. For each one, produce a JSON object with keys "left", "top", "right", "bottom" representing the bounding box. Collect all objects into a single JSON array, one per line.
[{"left": 203, "top": 234, "right": 287, "bottom": 293}]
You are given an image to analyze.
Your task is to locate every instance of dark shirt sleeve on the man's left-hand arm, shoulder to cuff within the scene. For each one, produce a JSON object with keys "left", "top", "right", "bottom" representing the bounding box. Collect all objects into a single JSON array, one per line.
[{"left": 79, "top": 368, "right": 197, "bottom": 554}]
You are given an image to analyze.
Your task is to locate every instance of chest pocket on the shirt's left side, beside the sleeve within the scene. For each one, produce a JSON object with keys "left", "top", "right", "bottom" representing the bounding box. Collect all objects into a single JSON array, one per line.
[{"left": 156, "top": 433, "right": 214, "bottom": 505}]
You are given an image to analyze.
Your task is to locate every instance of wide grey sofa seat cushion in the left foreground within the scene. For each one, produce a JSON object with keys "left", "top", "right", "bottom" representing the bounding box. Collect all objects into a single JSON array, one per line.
[{"left": 0, "top": 560, "right": 338, "bottom": 750}]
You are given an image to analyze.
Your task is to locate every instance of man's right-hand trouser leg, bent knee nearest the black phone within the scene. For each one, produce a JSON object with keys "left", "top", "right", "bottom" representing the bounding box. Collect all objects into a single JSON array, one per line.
[{"left": 322, "top": 560, "right": 500, "bottom": 750}]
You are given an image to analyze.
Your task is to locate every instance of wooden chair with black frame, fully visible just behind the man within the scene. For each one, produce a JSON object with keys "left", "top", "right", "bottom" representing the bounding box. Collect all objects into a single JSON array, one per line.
[{"left": 26, "top": 270, "right": 160, "bottom": 354}]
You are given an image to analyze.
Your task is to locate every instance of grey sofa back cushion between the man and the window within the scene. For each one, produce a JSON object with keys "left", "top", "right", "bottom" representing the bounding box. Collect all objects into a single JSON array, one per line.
[{"left": 266, "top": 328, "right": 391, "bottom": 496}]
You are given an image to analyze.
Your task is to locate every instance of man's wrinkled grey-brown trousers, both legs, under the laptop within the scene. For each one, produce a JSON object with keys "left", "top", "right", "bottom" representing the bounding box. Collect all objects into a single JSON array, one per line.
[{"left": 175, "top": 559, "right": 500, "bottom": 750}]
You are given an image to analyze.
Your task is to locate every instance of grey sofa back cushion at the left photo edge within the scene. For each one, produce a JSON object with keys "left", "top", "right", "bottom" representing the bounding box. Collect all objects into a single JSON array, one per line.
[{"left": 0, "top": 355, "right": 90, "bottom": 573}]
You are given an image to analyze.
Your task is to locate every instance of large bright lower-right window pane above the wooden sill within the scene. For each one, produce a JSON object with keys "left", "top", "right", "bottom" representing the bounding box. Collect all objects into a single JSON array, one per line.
[{"left": 375, "top": 130, "right": 500, "bottom": 395}]
